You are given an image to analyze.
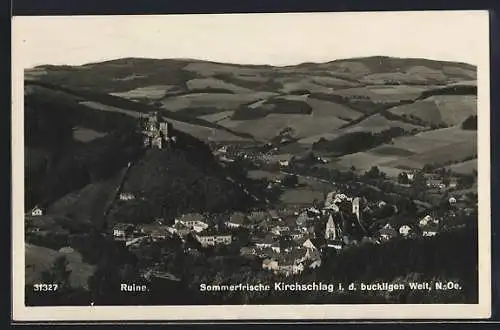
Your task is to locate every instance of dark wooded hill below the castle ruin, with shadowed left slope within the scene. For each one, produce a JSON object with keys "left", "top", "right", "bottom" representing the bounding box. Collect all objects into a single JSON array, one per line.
[{"left": 25, "top": 81, "right": 251, "bottom": 221}]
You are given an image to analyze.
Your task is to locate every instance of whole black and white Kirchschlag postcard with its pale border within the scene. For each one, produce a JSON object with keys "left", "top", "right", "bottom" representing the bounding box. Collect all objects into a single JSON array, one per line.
[{"left": 12, "top": 11, "right": 491, "bottom": 321}]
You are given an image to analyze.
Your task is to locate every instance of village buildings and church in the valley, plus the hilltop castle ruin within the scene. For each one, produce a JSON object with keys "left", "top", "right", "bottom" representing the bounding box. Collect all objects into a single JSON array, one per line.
[{"left": 28, "top": 114, "right": 477, "bottom": 284}]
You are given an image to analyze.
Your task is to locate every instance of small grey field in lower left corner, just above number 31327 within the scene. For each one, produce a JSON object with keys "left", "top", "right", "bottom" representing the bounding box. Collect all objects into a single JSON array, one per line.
[{"left": 25, "top": 244, "right": 95, "bottom": 288}]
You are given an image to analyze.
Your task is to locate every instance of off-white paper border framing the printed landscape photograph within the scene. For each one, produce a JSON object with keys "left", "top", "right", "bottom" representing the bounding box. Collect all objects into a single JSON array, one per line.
[{"left": 11, "top": 11, "right": 491, "bottom": 321}]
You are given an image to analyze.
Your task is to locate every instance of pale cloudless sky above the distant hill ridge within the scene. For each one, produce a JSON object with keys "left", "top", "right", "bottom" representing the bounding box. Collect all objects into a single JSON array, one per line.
[{"left": 12, "top": 11, "right": 489, "bottom": 68}]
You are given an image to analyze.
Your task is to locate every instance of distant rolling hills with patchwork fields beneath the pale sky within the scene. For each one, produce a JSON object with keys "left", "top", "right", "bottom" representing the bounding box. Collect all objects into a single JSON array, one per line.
[{"left": 26, "top": 56, "right": 477, "bottom": 182}]
